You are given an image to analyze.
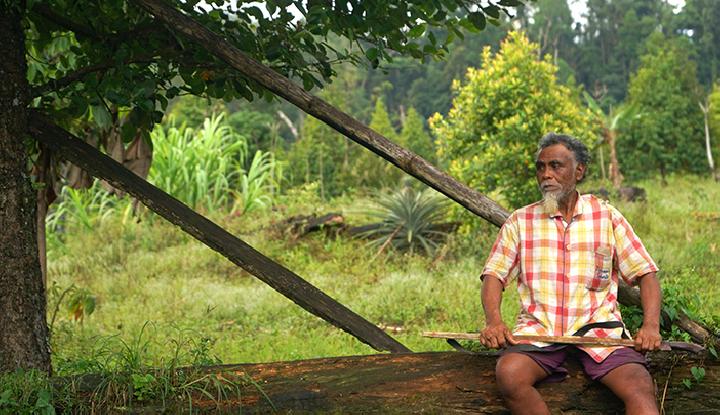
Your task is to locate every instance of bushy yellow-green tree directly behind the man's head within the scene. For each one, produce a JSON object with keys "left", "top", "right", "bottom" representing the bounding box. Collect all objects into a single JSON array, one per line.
[{"left": 431, "top": 32, "right": 595, "bottom": 207}]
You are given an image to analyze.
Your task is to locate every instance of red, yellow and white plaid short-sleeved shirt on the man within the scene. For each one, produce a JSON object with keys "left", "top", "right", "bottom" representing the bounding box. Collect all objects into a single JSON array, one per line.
[{"left": 482, "top": 195, "right": 657, "bottom": 362}]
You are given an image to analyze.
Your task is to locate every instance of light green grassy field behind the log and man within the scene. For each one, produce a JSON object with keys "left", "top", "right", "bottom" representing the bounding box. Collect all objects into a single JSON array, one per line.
[{"left": 48, "top": 177, "right": 720, "bottom": 373}]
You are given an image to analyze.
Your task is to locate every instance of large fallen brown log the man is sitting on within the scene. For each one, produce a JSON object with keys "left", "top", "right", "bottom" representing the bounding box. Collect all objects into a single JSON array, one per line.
[{"left": 71, "top": 352, "right": 720, "bottom": 414}]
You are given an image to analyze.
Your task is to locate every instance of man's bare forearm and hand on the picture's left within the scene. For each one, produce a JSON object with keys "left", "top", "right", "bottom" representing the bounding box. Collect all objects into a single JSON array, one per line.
[{"left": 480, "top": 275, "right": 516, "bottom": 349}]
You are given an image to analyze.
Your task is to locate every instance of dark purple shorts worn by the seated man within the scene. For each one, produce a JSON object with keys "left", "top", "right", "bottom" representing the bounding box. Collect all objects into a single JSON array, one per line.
[{"left": 500, "top": 345, "right": 647, "bottom": 382}]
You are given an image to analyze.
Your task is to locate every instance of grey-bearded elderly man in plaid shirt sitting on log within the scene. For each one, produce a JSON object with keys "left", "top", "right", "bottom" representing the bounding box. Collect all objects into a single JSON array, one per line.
[{"left": 481, "top": 133, "right": 661, "bottom": 414}]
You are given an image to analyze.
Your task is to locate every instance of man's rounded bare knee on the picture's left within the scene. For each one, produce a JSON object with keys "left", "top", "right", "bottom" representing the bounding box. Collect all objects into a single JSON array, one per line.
[{"left": 495, "top": 353, "right": 547, "bottom": 396}]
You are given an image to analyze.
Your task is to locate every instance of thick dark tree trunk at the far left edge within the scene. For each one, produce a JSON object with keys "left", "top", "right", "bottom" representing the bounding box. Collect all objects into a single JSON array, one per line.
[{"left": 0, "top": 2, "right": 50, "bottom": 372}]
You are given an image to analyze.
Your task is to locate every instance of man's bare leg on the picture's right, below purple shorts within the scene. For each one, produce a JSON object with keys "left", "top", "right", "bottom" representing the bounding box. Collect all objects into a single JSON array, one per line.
[{"left": 600, "top": 363, "right": 658, "bottom": 415}]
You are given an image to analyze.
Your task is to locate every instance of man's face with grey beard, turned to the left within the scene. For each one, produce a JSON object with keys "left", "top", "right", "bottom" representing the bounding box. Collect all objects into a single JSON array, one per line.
[{"left": 535, "top": 144, "right": 585, "bottom": 201}]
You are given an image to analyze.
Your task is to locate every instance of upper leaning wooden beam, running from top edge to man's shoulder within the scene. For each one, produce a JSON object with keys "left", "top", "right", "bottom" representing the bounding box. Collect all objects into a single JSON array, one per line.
[{"left": 134, "top": 0, "right": 508, "bottom": 231}]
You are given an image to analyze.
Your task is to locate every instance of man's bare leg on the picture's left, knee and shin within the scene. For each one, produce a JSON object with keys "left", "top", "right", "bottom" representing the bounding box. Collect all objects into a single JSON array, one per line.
[{"left": 495, "top": 353, "right": 550, "bottom": 415}]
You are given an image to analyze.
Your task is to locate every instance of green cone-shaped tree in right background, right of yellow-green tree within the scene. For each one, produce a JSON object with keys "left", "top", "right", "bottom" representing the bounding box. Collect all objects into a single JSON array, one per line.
[{"left": 618, "top": 33, "right": 706, "bottom": 178}]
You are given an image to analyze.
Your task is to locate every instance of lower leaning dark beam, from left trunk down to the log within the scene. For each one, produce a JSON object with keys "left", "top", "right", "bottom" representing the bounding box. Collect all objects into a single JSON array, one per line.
[{"left": 29, "top": 113, "right": 410, "bottom": 352}]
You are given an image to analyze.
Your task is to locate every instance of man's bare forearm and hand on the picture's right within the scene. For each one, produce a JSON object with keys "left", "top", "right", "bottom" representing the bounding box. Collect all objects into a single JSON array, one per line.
[{"left": 635, "top": 272, "right": 662, "bottom": 352}]
